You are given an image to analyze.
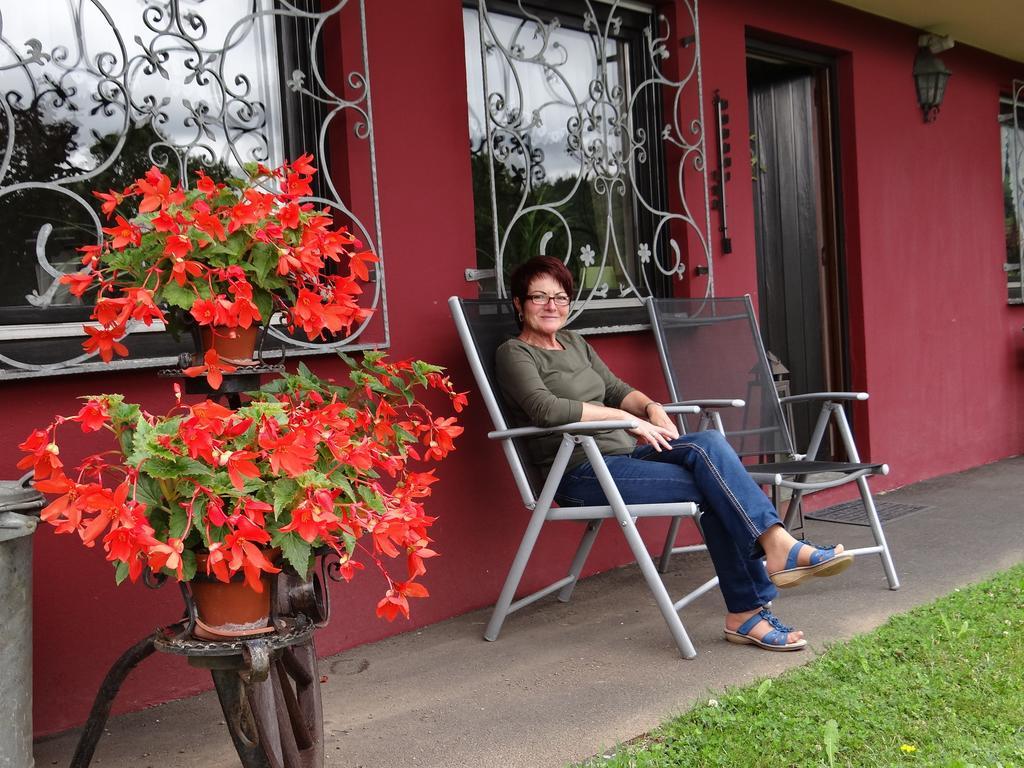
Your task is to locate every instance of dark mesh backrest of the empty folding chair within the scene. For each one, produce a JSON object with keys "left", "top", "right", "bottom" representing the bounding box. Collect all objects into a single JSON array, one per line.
[{"left": 647, "top": 296, "right": 794, "bottom": 456}]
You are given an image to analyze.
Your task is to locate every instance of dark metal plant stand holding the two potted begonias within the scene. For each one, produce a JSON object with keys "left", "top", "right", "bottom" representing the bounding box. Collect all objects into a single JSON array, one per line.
[{"left": 71, "top": 337, "right": 341, "bottom": 768}]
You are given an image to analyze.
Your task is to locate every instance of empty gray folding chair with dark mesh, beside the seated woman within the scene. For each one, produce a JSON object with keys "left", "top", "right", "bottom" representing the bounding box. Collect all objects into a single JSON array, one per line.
[{"left": 647, "top": 296, "right": 899, "bottom": 590}]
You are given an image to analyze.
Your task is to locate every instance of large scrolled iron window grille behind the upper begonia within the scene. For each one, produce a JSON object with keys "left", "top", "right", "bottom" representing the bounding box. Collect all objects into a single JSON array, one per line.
[{"left": 0, "top": 0, "right": 389, "bottom": 378}]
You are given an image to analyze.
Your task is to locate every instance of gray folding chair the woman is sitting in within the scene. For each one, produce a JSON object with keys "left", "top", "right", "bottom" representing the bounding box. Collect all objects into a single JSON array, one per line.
[{"left": 449, "top": 296, "right": 718, "bottom": 658}]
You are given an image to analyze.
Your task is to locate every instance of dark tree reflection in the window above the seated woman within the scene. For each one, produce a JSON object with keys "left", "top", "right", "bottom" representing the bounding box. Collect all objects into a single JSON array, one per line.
[{"left": 470, "top": 134, "right": 632, "bottom": 289}]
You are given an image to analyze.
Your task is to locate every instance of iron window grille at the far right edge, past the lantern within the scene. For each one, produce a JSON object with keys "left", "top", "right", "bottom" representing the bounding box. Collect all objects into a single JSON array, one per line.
[{"left": 999, "top": 80, "right": 1024, "bottom": 304}]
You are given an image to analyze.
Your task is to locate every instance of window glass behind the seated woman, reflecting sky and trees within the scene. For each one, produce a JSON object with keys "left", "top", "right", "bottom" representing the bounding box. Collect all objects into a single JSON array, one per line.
[{"left": 464, "top": 8, "right": 640, "bottom": 307}]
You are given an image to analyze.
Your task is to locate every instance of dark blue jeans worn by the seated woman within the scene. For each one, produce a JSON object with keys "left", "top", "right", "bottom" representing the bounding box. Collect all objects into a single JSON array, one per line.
[{"left": 557, "top": 430, "right": 780, "bottom": 613}]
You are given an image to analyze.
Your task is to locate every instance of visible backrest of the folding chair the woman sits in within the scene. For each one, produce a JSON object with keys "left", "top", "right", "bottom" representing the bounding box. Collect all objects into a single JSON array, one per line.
[{"left": 449, "top": 296, "right": 544, "bottom": 507}]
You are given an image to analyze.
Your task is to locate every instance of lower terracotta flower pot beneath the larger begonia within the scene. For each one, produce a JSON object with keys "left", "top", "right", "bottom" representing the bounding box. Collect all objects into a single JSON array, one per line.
[{"left": 191, "top": 555, "right": 273, "bottom": 640}]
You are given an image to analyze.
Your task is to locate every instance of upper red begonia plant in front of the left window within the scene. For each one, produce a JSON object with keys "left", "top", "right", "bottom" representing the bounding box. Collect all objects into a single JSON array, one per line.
[{"left": 61, "top": 155, "right": 377, "bottom": 388}]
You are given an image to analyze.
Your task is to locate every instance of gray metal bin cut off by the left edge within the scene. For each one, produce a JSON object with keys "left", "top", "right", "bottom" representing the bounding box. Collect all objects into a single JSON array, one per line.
[{"left": 0, "top": 478, "right": 45, "bottom": 768}]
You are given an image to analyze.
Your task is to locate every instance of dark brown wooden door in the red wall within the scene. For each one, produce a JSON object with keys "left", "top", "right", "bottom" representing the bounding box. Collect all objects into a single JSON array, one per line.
[{"left": 748, "top": 50, "right": 847, "bottom": 458}]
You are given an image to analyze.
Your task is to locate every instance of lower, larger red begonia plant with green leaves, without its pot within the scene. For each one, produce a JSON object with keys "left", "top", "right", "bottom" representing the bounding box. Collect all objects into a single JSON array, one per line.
[{"left": 18, "top": 352, "right": 466, "bottom": 621}]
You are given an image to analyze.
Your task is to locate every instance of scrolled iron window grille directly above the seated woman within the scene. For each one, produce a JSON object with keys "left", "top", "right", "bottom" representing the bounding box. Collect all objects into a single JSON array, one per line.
[{"left": 465, "top": 0, "right": 714, "bottom": 322}]
